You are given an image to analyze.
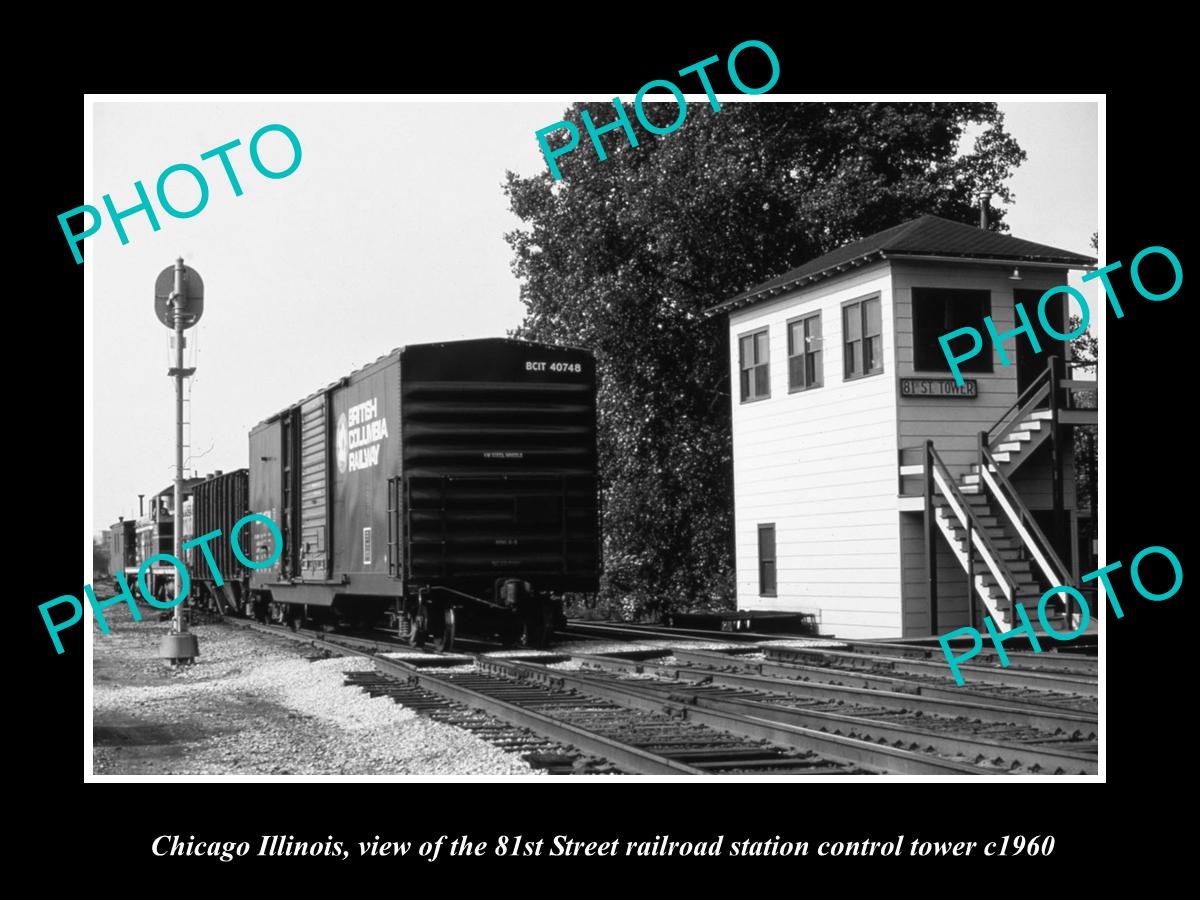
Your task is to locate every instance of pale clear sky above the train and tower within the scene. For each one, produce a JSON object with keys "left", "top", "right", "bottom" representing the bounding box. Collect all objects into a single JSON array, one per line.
[{"left": 83, "top": 96, "right": 1098, "bottom": 532}]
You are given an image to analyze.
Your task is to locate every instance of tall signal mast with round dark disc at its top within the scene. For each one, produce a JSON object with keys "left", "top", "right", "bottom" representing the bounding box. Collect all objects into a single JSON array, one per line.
[{"left": 155, "top": 257, "right": 204, "bottom": 666}]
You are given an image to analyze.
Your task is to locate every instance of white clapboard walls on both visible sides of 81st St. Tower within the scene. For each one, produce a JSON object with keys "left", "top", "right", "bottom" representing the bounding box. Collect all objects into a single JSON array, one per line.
[{"left": 730, "top": 260, "right": 1075, "bottom": 637}]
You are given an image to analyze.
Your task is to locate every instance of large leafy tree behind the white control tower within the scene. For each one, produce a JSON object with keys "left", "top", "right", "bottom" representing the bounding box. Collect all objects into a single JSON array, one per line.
[{"left": 505, "top": 103, "right": 1025, "bottom": 614}]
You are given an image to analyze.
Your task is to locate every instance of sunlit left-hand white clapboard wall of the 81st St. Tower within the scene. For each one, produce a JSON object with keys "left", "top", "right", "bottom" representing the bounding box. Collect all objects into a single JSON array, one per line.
[{"left": 730, "top": 263, "right": 901, "bottom": 637}]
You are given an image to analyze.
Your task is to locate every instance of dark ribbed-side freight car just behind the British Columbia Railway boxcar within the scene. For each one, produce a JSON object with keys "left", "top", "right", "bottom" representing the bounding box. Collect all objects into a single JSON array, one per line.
[{"left": 184, "top": 469, "right": 251, "bottom": 612}]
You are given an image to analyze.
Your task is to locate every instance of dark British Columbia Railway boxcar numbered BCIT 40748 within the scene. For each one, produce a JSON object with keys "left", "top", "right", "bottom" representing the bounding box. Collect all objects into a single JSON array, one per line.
[{"left": 250, "top": 338, "right": 600, "bottom": 647}]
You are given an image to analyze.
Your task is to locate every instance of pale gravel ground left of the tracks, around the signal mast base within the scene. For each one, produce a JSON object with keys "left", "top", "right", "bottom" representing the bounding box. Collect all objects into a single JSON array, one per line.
[{"left": 92, "top": 606, "right": 540, "bottom": 775}]
